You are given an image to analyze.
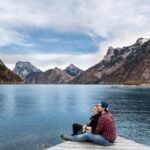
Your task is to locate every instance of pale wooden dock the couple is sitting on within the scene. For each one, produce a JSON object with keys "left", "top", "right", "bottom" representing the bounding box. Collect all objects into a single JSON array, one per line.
[{"left": 46, "top": 136, "right": 150, "bottom": 150}]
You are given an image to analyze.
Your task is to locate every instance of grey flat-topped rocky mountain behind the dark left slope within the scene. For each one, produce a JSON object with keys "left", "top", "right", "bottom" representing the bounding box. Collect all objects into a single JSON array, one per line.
[{"left": 13, "top": 61, "right": 42, "bottom": 80}]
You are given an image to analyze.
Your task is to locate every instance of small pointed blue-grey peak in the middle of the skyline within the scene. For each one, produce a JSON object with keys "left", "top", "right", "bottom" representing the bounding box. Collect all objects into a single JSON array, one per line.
[{"left": 64, "top": 64, "right": 83, "bottom": 77}]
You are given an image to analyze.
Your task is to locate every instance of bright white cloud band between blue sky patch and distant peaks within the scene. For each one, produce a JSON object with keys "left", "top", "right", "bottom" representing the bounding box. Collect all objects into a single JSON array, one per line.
[{"left": 0, "top": 54, "right": 101, "bottom": 71}]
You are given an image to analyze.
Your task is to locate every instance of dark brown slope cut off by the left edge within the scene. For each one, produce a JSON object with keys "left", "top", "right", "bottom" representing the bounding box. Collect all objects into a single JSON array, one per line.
[{"left": 0, "top": 60, "right": 22, "bottom": 84}]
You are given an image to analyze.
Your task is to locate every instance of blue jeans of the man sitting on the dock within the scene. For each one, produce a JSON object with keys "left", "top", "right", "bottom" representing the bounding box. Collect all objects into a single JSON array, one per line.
[{"left": 70, "top": 133, "right": 113, "bottom": 146}]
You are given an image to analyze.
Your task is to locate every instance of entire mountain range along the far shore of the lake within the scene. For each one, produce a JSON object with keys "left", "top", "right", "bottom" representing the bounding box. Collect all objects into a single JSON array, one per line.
[{"left": 0, "top": 38, "right": 150, "bottom": 85}]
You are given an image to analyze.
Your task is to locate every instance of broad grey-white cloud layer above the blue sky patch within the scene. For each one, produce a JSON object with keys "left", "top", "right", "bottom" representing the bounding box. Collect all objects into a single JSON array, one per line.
[{"left": 0, "top": 0, "right": 150, "bottom": 40}]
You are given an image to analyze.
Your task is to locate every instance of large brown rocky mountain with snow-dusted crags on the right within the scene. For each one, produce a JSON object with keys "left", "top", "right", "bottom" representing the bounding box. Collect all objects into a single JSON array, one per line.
[{"left": 69, "top": 38, "right": 150, "bottom": 84}]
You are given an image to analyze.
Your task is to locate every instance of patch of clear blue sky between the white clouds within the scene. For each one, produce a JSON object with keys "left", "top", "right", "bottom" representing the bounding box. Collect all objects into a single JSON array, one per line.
[{"left": 0, "top": 29, "right": 104, "bottom": 54}]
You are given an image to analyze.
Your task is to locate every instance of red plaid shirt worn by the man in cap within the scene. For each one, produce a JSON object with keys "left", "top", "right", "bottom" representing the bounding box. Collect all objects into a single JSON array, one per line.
[{"left": 95, "top": 112, "right": 116, "bottom": 143}]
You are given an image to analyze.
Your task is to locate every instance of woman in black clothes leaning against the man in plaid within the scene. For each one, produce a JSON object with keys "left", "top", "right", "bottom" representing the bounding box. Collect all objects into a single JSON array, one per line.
[{"left": 72, "top": 105, "right": 101, "bottom": 135}]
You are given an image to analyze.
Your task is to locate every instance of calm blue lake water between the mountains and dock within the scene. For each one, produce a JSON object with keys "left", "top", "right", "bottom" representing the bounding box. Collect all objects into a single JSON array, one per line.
[{"left": 0, "top": 85, "right": 150, "bottom": 150}]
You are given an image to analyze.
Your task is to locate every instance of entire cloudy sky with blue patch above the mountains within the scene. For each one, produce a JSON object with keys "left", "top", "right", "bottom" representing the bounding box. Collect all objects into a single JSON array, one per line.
[{"left": 0, "top": 0, "right": 150, "bottom": 71}]
